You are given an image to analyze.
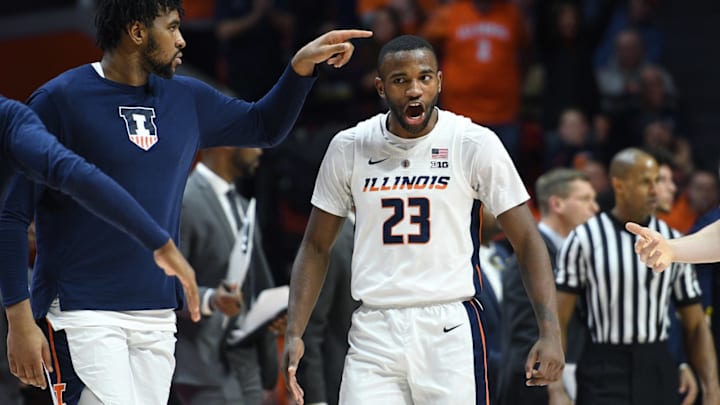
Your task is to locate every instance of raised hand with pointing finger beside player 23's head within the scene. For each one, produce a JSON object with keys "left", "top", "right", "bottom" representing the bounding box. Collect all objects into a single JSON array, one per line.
[{"left": 292, "top": 30, "right": 372, "bottom": 76}]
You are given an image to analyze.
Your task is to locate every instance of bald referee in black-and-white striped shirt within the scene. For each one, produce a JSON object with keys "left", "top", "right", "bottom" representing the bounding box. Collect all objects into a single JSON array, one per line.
[{"left": 556, "top": 148, "right": 720, "bottom": 405}]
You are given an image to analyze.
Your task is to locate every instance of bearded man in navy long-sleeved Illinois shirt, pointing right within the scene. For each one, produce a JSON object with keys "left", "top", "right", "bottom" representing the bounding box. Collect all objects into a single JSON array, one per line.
[{"left": 0, "top": 0, "right": 371, "bottom": 404}]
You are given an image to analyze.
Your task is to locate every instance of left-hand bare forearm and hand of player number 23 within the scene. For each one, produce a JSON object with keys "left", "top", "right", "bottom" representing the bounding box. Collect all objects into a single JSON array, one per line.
[{"left": 283, "top": 207, "right": 345, "bottom": 405}]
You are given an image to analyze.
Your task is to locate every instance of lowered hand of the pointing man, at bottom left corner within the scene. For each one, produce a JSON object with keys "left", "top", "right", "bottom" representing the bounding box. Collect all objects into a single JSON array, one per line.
[{"left": 6, "top": 300, "right": 52, "bottom": 389}]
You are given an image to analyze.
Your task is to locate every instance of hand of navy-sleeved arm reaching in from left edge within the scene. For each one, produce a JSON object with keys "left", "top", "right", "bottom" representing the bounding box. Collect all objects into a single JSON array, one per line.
[{"left": 153, "top": 239, "right": 200, "bottom": 322}]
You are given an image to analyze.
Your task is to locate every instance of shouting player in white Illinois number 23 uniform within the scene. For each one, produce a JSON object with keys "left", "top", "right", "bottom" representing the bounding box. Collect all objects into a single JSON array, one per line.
[{"left": 283, "top": 36, "right": 564, "bottom": 404}]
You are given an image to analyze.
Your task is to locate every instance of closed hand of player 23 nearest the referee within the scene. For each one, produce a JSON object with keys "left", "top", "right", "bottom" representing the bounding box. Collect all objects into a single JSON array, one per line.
[{"left": 525, "top": 336, "right": 565, "bottom": 387}]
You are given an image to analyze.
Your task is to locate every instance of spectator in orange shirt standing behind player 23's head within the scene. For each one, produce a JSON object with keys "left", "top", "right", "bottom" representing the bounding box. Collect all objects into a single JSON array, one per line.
[{"left": 422, "top": 0, "right": 529, "bottom": 164}]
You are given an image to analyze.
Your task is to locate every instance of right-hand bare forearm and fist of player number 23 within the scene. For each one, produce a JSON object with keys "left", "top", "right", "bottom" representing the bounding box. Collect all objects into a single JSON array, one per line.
[{"left": 497, "top": 203, "right": 565, "bottom": 385}]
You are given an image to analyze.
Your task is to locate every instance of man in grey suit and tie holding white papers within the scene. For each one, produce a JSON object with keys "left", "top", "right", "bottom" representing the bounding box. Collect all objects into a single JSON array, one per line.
[{"left": 172, "top": 148, "right": 287, "bottom": 405}]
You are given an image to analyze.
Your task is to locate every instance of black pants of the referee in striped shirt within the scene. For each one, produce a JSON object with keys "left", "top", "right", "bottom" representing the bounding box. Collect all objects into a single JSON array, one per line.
[{"left": 575, "top": 342, "right": 680, "bottom": 405}]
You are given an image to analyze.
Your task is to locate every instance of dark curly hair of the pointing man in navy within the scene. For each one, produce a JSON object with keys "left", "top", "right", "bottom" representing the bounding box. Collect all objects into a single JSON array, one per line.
[{"left": 95, "top": 0, "right": 185, "bottom": 51}]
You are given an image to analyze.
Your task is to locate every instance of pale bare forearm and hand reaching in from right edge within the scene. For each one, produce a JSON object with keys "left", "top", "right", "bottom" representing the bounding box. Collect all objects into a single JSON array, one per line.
[{"left": 625, "top": 221, "right": 720, "bottom": 271}]
